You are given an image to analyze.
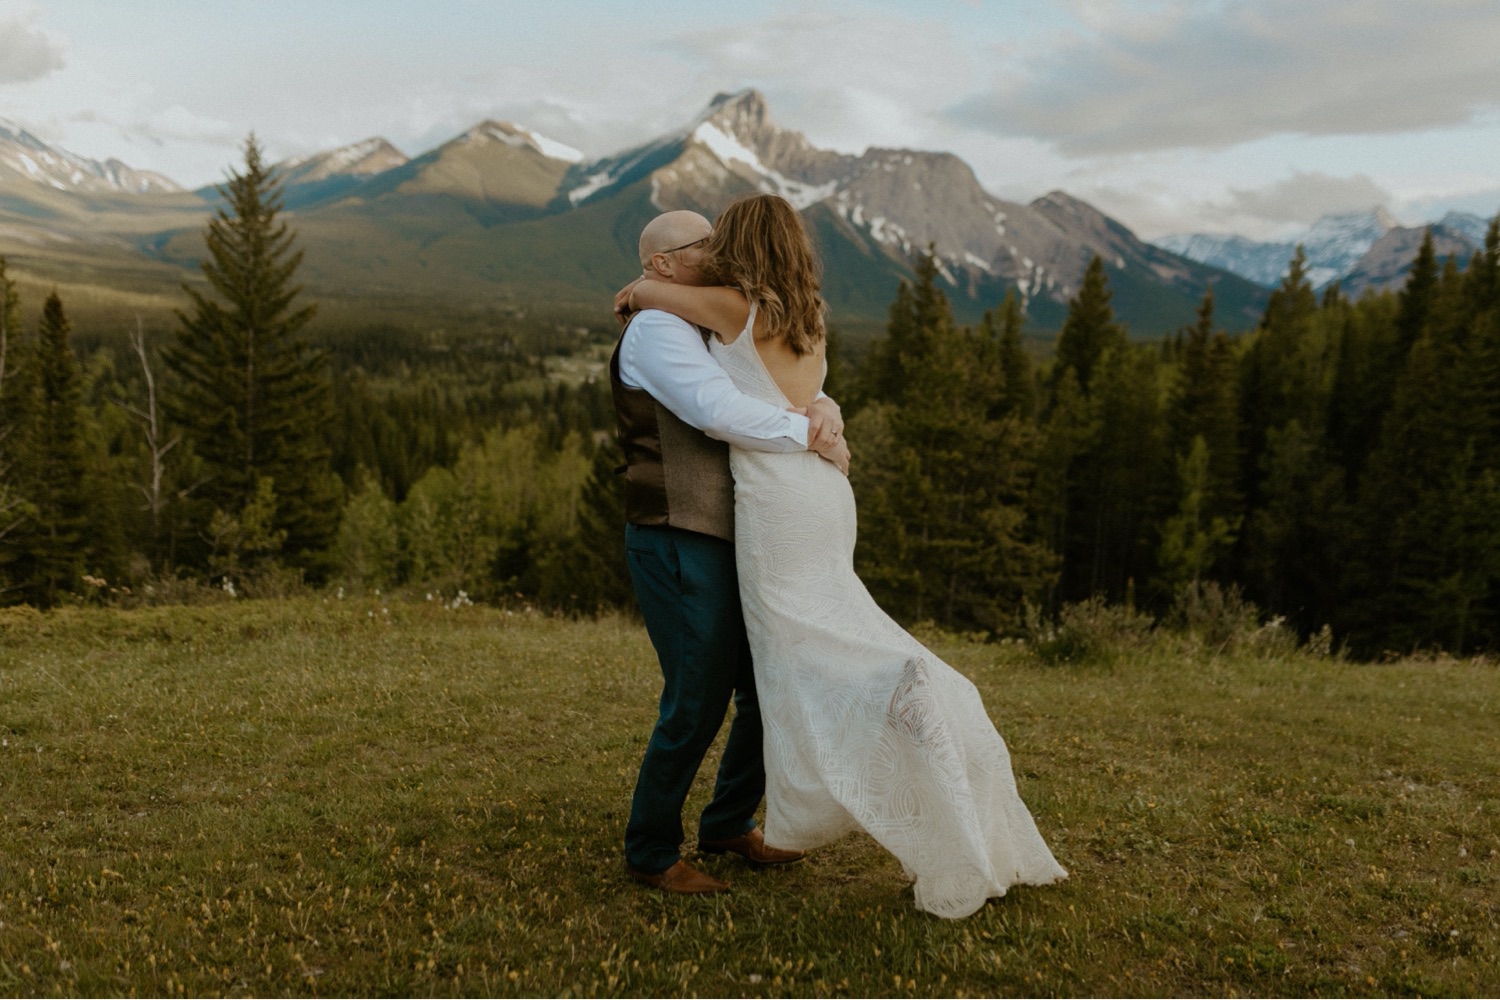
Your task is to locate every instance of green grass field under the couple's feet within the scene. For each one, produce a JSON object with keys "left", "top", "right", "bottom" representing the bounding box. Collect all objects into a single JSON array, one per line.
[{"left": 0, "top": 597, "right": 1500, "bottom": 996}]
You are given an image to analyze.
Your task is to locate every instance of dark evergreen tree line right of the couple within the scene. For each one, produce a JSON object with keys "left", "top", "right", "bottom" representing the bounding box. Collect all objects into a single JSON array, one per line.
[{"left": 848, "top": 230, "right": 1500, "bottom": 655}]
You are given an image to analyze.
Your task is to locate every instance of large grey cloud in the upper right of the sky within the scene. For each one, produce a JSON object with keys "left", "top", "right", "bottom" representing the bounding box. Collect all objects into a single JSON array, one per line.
[{"left": 948, "top": 0, "right": 1500, "bottom": 156}]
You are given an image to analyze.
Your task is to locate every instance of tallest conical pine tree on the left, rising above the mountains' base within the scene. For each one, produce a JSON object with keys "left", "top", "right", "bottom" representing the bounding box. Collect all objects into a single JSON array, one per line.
[{"left": 165, "top": 135, "right": 341, "bottom": 571}]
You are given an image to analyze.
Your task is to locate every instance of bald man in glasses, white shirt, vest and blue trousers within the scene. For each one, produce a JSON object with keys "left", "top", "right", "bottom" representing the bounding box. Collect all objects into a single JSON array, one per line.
[{"left": 609, "top": 211, "right": 849, "bottom": 894}]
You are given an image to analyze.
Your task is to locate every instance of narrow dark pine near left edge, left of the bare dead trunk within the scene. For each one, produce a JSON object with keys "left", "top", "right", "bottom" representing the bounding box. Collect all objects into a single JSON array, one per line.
[{"left": 26, "top": 291, "right": 86, "bottom": 607}]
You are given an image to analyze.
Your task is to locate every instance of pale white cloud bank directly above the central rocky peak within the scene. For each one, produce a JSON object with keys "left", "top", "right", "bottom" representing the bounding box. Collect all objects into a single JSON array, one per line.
[{"left": 380, "top": 3, "right": 978, "bottom": 166}]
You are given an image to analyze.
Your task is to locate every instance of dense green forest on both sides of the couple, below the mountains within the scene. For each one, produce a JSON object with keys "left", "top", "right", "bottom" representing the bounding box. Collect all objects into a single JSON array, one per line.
[{"left": 0, "top": 144, "right": 1500, "bottom": 655}]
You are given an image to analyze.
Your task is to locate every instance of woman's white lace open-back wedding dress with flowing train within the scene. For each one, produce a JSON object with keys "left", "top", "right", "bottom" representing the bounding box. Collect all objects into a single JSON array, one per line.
[{"left": 710, "top": 309, "right": 1068, "bottom": 918}]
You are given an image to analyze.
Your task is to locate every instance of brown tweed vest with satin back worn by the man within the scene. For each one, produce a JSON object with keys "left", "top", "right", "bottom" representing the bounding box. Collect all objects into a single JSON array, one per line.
[{"left": 609, "top": 319, "right": 735, "bottom": 541}]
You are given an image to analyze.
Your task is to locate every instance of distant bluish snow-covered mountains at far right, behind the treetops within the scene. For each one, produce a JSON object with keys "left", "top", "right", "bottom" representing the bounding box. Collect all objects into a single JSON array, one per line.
[{"left": 1157, "top": 207, "right": 1488, "bottom": 297}]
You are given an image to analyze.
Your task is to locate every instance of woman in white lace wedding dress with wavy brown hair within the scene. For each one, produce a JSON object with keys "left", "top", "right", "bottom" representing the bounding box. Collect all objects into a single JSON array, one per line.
[{"left": 618, "top": 195, "right": 1068, "bottom": 918}]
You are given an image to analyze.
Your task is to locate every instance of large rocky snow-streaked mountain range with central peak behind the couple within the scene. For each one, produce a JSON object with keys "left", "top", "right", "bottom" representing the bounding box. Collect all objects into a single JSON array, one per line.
[{"left": 0, "top": 90, "right": 1416, "bottom": 336}]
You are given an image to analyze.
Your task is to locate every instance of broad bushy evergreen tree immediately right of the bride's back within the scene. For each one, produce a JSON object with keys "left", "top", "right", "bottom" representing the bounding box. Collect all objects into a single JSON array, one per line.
[{"left": 849, "top": 256, "right": 1052, "bottom": 631}]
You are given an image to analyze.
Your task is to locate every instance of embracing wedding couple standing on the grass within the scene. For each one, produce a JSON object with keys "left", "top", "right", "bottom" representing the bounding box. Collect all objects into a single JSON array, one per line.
[{"left": 609, "top": 195, "right": 1067, "bottom": 918}]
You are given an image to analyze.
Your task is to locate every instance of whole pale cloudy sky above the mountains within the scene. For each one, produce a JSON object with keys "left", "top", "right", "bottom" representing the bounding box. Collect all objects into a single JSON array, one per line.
[{"left": 0, "top": 0, "right": 1500, "bottom": 238}]
